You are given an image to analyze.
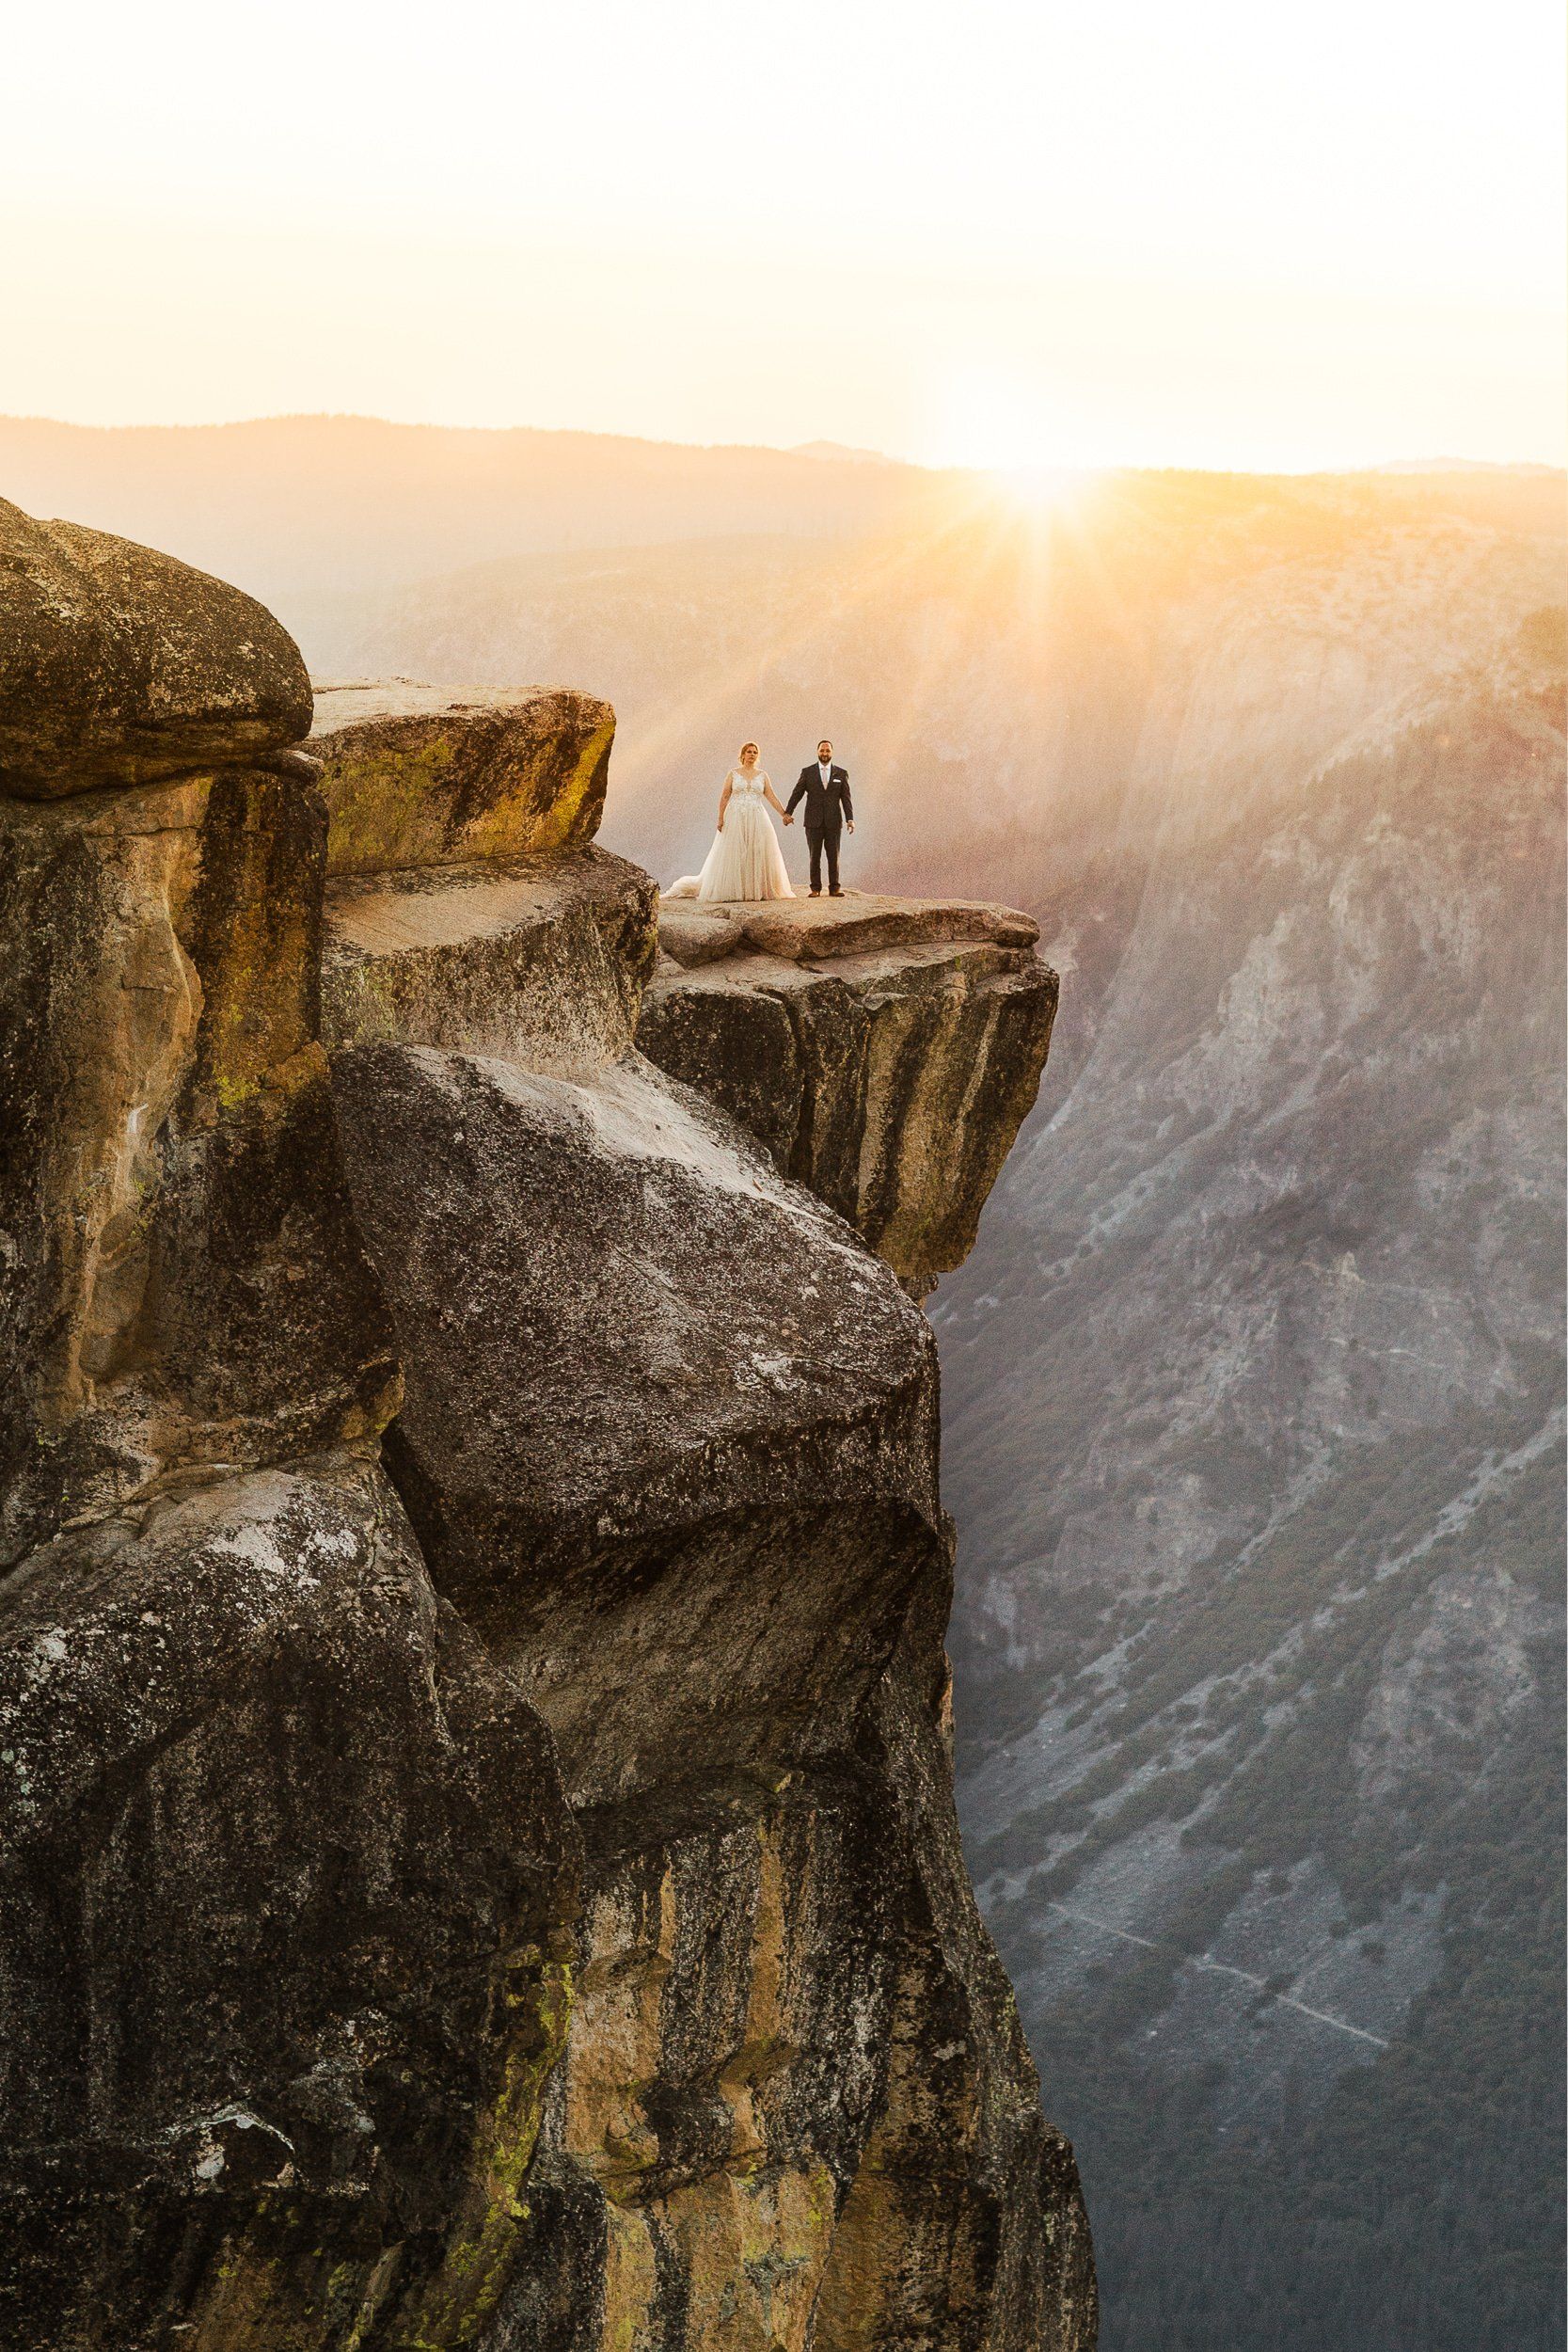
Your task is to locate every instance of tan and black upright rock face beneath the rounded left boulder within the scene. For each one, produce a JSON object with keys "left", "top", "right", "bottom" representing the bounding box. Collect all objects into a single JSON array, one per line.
[{"left": 0, "top": 767, "right": 395, "bottom": 1562}]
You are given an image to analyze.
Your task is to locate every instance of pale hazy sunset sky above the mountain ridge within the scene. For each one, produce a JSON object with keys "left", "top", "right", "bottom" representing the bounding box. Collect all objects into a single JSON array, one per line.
[{"left": 0, "top": 0, "right": 1566, "bottom": 469}]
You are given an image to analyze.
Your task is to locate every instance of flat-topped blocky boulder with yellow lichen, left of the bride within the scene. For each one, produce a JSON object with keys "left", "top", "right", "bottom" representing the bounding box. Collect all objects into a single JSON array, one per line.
[{"left": 310, "top": 687, "right": 616, "bottom": 875}]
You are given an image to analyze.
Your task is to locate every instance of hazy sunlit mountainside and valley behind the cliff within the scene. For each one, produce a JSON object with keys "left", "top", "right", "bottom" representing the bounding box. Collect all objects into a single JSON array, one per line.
[{"left": 0, "top": 436, "right": 1566, "bottom": 2352}]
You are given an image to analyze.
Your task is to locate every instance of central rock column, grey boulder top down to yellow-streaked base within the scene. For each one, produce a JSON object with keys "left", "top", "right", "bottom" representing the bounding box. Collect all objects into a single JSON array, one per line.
[{"left": 334, "top": 1044, "right": 1093, "bottom": 2352}]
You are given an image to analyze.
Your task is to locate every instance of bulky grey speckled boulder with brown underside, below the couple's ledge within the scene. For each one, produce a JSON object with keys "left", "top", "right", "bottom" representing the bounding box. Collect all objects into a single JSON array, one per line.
[{"left": 334, "top": 1047, "right": 947, "bottom": 1804}]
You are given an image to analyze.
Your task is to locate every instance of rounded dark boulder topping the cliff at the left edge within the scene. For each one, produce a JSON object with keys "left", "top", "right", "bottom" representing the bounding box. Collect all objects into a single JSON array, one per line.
[{"left": 0, "top": 499, "right": 310, "bottom": 800}]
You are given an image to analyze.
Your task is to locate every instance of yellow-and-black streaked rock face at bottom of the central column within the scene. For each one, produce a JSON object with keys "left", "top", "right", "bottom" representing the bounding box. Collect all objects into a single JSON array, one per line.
[{"left": 505, "top": 1710, "right": 1093, "bottom": 2352}]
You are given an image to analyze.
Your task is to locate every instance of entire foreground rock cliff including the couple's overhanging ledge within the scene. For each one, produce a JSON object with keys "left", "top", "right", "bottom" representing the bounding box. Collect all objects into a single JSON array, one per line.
[{"left": 0, "top": 508, "right": 1096, "bottom": 2352}]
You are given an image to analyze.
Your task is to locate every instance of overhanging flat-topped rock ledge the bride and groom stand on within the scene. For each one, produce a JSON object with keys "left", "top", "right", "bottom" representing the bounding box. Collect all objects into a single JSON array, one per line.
[{"left": 637, "top": 898, "right": 1058, "bottom": 1298}]
